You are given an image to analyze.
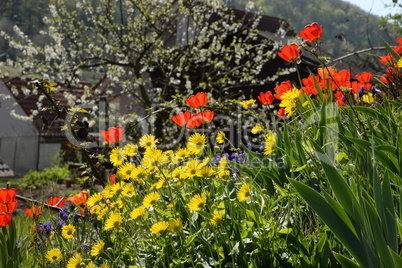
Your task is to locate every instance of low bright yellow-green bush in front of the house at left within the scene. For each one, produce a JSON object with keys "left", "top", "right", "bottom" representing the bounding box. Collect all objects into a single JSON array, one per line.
[{"left": 19, "top": 164, "right": 70, "bottom": 189}]
